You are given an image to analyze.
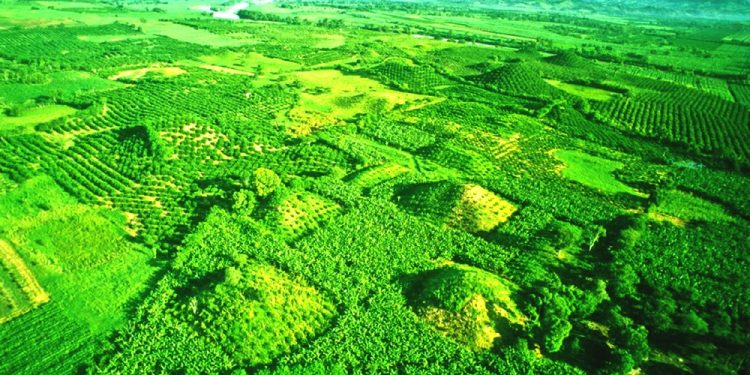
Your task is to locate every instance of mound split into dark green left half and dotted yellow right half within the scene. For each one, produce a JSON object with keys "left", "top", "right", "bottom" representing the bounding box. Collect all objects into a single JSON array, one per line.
[{"left": 396, "top": 181, "right": 516, "bottom": 233}]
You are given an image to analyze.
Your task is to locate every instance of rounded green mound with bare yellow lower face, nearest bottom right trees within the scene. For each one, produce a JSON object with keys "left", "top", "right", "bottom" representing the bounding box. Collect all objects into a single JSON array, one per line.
[{"left": 412, "top": 264, "right": 526, "bottom": 349}]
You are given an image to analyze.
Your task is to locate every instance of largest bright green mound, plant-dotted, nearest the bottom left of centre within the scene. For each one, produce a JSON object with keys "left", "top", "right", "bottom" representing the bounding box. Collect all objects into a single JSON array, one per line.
[{"left": 184, "top": 262, "right": 334, "bottom": 365}]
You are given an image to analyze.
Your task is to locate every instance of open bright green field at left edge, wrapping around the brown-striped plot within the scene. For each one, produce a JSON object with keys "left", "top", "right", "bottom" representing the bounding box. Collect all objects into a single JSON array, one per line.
[{"left": 0, "top": 176, "right": 156, "bottom": 373}]
